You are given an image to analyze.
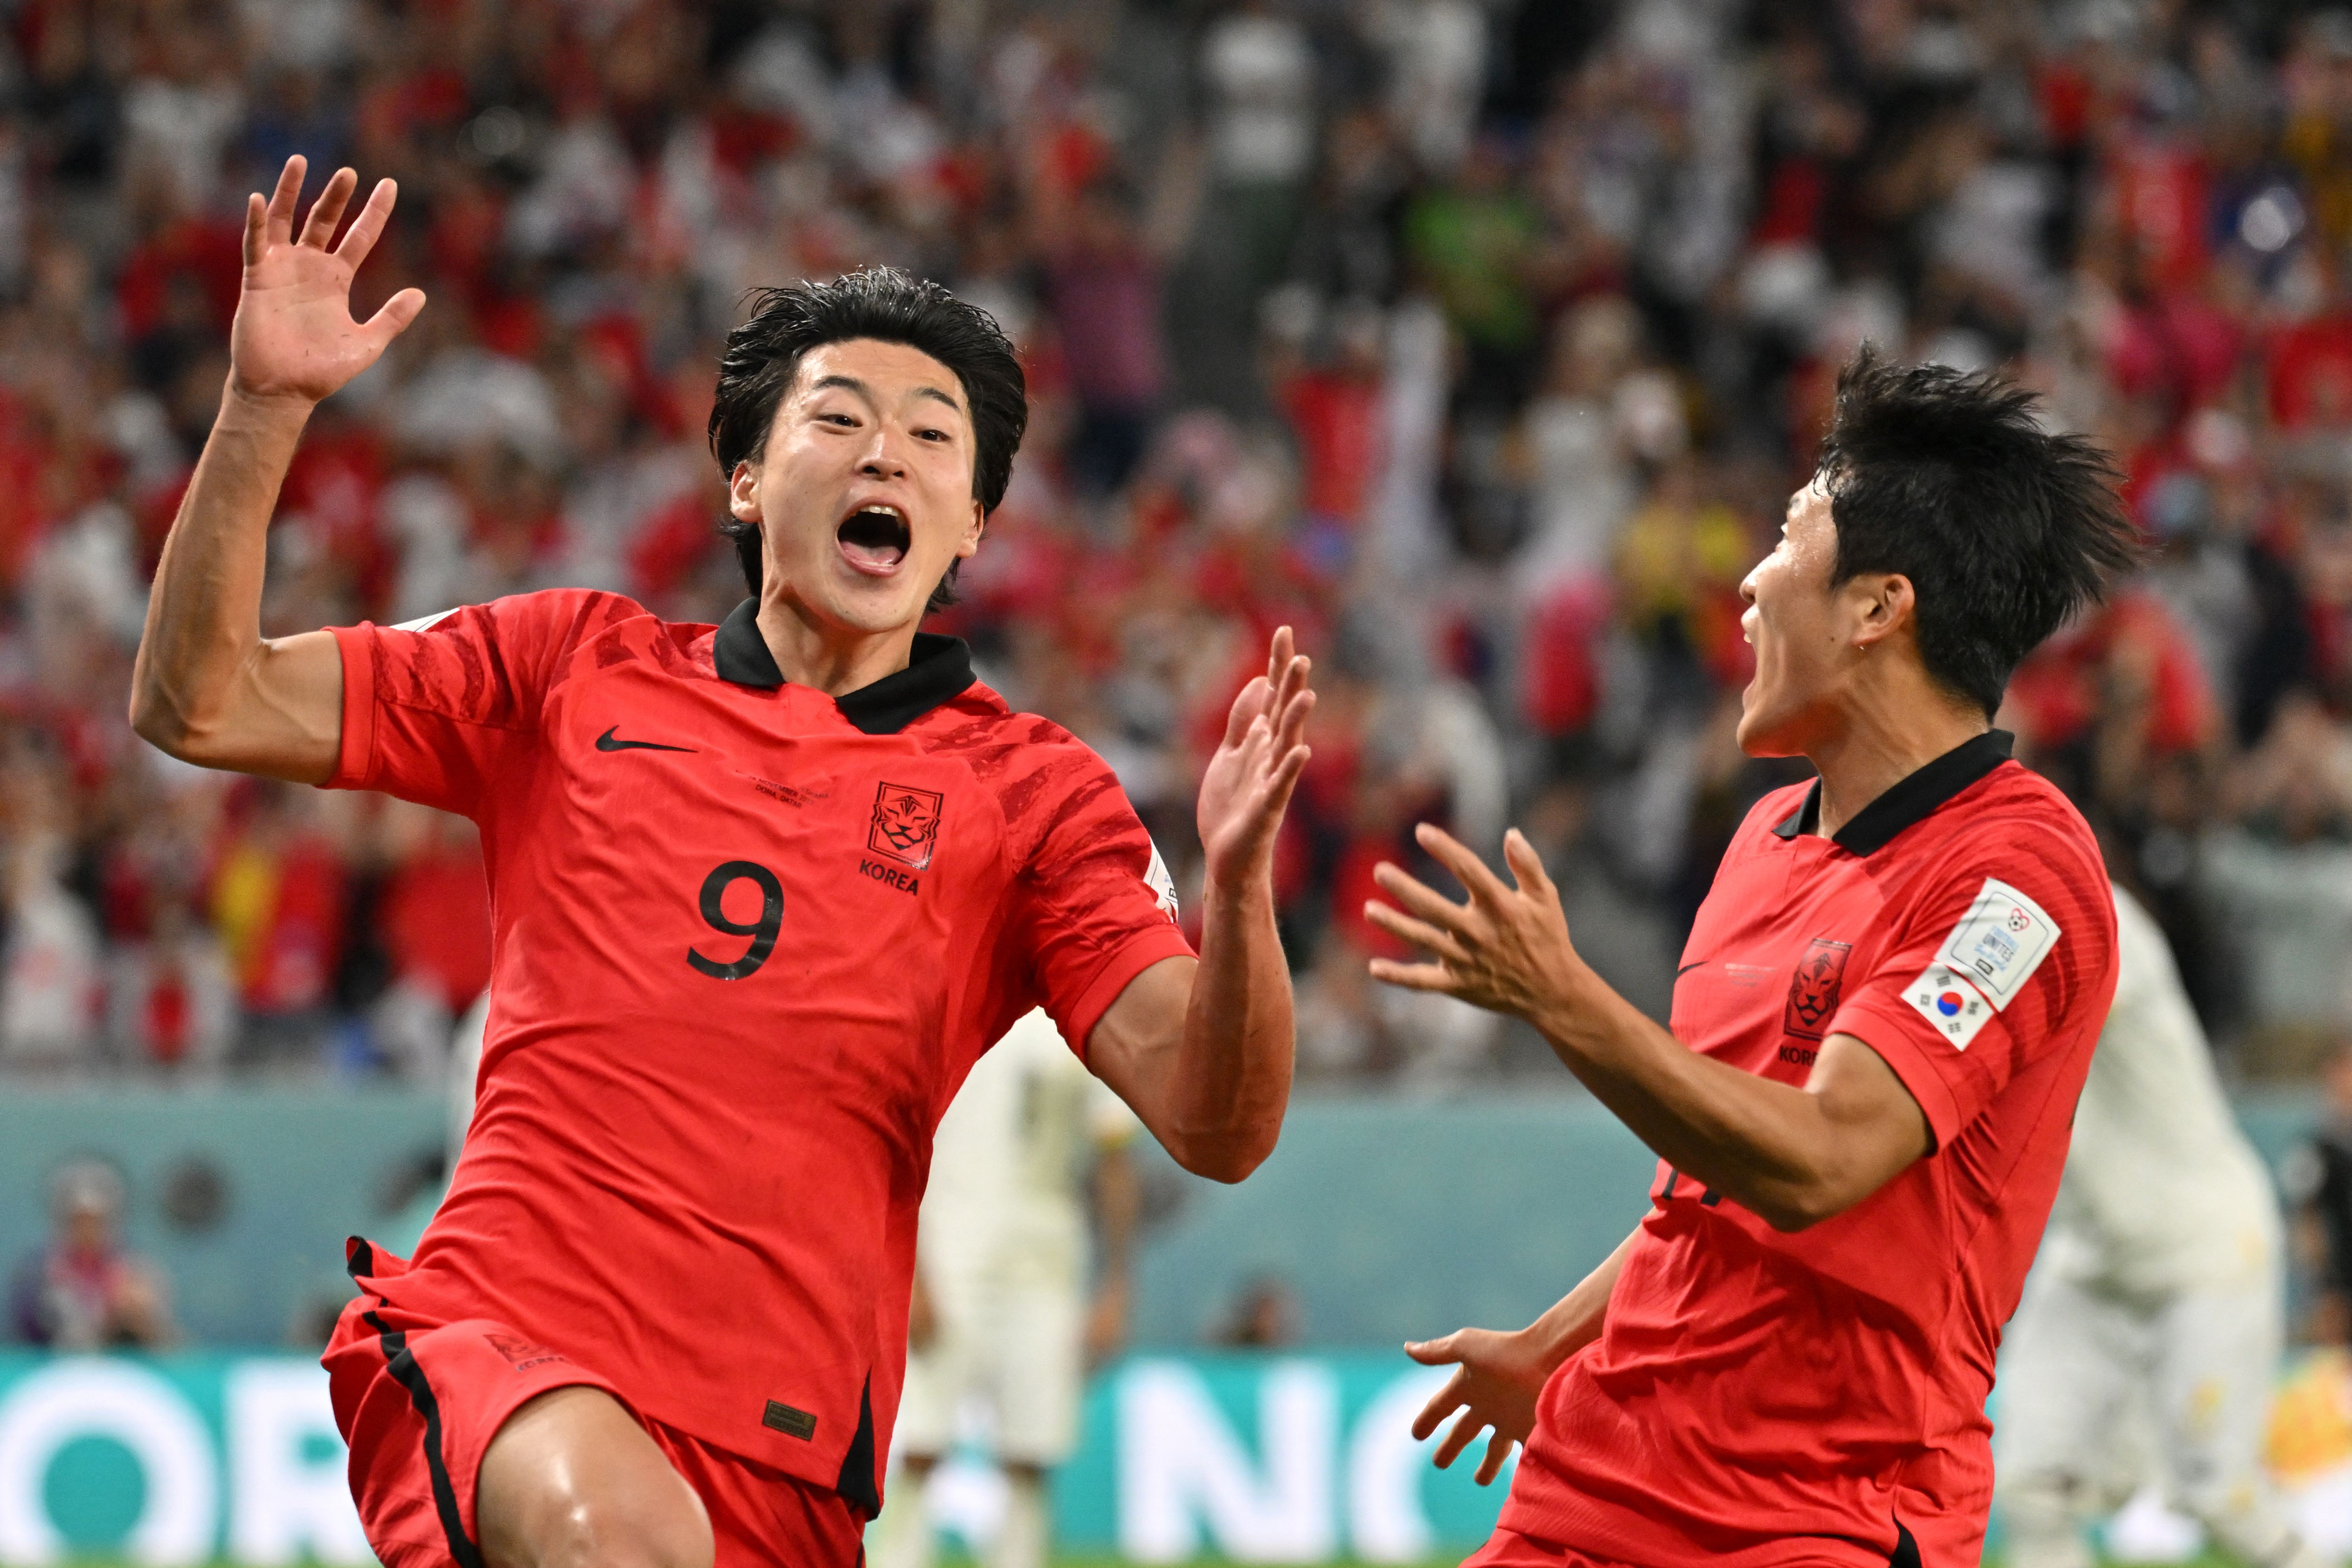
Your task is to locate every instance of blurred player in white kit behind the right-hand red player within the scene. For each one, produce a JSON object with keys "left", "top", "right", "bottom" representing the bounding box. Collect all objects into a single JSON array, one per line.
[{"left": 1992, "top": 889, "right": 2321, "bottom": 1568}]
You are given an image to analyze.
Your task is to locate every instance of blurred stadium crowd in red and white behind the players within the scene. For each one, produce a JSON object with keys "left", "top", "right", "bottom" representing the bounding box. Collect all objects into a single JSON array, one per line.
[{"left": 0, "top": 0, "right": 2352, "bottom": 1091}]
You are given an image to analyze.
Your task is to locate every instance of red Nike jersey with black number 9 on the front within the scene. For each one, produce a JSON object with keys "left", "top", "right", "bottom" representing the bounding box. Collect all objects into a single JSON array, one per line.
[{"left": 329, "top": 590, "right": 1190, "bottom": 1512}]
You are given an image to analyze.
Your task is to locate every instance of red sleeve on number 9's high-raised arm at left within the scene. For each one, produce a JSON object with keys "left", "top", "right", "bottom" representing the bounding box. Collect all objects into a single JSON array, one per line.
[{"left": 327, "top": 590, "right": 637, "bottom": 816}]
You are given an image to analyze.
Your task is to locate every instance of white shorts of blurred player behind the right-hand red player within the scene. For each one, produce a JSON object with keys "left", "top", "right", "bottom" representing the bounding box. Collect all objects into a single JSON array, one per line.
[{"left": 1992, "top": 1270, "right": 2282, "bottom": 1545}]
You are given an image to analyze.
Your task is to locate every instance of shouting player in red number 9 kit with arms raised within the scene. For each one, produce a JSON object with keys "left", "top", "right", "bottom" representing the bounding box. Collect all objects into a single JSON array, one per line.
[{"left": 132, "top": 158, "right": 1312, "bottom": 1568}]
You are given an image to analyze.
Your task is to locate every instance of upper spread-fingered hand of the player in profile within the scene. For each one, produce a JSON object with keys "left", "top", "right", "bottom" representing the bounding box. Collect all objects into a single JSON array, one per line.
[{"left": 1364, "top": 823, "right": 1581, "bottom": 1023}]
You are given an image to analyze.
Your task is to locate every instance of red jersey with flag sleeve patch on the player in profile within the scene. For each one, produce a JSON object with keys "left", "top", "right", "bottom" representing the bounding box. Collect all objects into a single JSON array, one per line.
[{"left": 1503, "top": 731, "right": 2114, "bottom": 1565}]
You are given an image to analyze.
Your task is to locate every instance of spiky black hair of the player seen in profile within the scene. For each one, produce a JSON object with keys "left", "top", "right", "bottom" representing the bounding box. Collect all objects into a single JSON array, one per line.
[{"left": 1818, "top": 345, "right": 2143, "bottom": 717}]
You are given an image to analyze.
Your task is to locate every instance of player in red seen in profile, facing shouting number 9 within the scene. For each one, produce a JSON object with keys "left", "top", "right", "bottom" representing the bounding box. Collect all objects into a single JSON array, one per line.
[{"left": 1371, "top": 353, "right": 2135, "bottom": 1568}]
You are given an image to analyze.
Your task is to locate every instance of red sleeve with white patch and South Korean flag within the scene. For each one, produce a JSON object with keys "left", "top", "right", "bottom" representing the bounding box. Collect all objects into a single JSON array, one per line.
[{"left": 1827, "top": 823, "right": 2114, "bottom": 1150}]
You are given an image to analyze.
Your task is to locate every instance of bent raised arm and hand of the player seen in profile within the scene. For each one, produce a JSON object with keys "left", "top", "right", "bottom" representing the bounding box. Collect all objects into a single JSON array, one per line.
[{"left": 1367, "top": 825, "right": 1933, "bottom": 1229}]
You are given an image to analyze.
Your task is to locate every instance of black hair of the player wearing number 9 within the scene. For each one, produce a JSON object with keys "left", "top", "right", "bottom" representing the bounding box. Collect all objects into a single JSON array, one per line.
[{"left": 710, "top": 266, "right": 1028, "bottom": 611}]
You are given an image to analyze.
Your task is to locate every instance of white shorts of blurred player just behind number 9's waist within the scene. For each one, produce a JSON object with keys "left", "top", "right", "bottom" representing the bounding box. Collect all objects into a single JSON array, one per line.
[{"left": 898, "top": 1279, "right": 1087, "bottom": 1467}]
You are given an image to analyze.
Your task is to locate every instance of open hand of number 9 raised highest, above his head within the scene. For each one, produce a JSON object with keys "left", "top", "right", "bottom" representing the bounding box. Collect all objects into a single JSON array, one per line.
[{"left": 228, "top": 158, "right": 426, "bottom": 404}]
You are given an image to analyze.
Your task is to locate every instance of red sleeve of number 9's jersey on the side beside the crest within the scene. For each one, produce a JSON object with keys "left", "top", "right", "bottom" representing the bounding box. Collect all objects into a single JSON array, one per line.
[{"left": 1014, "top": 740, "right": 1193, "bottom": 1058}]
